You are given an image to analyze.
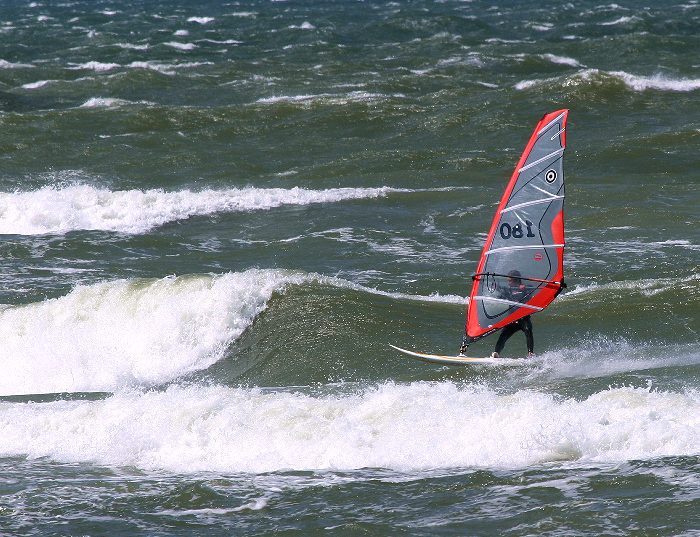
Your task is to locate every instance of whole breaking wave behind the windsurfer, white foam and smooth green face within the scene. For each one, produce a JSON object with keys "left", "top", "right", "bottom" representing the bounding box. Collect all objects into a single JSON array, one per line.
[{"left": 0, "top": 269, "right": 700, "bottom": 396}]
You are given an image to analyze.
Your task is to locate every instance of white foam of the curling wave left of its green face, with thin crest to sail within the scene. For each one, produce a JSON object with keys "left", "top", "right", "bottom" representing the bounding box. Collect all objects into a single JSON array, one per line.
[{"left": 0, "top": 269, "right": 462, "bottom": 395}]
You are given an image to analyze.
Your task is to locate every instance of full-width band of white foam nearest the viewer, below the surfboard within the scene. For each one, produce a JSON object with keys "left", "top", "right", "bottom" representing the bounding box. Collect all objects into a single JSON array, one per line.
[{"left": 0, "top": 382, "right": 700, "bottom": 473}]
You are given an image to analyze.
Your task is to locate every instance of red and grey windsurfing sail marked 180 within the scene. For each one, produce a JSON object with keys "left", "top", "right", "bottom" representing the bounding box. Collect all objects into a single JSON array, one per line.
[{"left": 466, "top": 110, "right": 569, "bottom": 339}]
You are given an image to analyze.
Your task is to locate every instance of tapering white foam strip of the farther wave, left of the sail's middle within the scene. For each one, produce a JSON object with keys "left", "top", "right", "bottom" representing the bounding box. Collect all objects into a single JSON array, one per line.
[{"left": 0, "top": 184, "right": 404, "bottom": 235}]
